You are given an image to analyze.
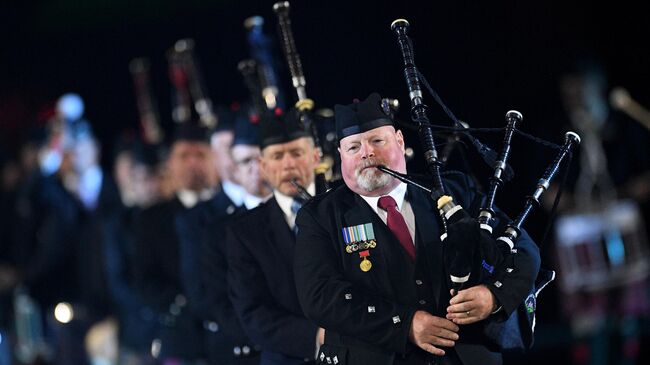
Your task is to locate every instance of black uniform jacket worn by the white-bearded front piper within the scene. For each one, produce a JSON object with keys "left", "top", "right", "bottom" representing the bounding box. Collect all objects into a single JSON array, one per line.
[{"left": 295, "top": 173, "right": 540, "bottom": 364}]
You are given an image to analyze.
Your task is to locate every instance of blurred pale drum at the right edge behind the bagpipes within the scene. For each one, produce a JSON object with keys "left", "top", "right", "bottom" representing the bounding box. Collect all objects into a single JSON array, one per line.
[{"left": 555, "top": 200, "right": 650, "bottom": 293}]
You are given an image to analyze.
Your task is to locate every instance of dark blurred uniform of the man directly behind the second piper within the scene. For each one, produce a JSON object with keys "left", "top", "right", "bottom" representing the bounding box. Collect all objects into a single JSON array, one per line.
[{"left": 176, "top": 190, "right": 259, "bottom": 365}]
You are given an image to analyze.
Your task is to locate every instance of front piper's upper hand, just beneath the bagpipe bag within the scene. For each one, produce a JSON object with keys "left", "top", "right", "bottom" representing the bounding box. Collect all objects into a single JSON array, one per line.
[{"left": 447, "top": 285, "right": 496, "bottom": 324}]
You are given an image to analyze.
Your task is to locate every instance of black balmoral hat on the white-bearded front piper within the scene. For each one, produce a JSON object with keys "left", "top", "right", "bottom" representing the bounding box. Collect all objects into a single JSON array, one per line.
[{"left": 334, "top": 93, "right": 394, "bottom": 142}]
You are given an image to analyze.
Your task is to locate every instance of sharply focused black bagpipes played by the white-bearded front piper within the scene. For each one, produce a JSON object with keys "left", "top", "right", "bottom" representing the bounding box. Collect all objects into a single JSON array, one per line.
[{"left": 380, "top": 19, "right": 580, "bottom": 316}]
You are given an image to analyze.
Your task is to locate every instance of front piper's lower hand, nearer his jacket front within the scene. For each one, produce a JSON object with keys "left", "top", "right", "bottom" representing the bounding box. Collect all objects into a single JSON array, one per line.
[{"left": 409, "top": 311, "right": 458, "bottom": 356}]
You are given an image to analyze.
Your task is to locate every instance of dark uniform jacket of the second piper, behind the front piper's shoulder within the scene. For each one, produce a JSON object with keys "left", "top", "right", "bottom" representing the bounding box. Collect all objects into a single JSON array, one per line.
[{"left": 227, "top": 198, "right": 317, "bottom": 365}]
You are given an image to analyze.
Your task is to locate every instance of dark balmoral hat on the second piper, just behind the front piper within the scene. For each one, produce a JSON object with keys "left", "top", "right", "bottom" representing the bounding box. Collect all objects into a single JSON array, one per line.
[{"left": 260, "top": 108, "right": 311, "bottom": 149}]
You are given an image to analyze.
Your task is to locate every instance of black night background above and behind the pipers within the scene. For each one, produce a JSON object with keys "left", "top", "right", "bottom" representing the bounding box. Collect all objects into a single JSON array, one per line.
[{"left": 0, "top": 0, "right": 650, "bottom": 362}]
